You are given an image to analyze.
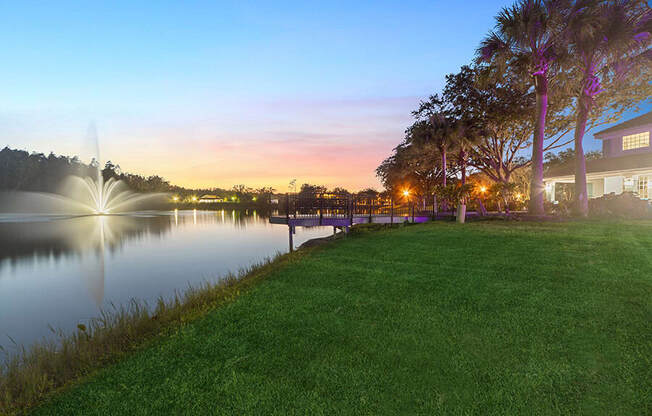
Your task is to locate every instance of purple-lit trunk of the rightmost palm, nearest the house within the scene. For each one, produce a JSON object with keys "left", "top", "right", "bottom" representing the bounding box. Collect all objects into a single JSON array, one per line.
[{"left": 573, "top": 93, "right": 592, "bottom": 217}]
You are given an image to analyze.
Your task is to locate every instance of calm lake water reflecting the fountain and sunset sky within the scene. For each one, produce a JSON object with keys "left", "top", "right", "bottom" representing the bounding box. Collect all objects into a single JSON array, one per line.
[{"left": 0, "top": 211, "right": 332, "bottom": 350}]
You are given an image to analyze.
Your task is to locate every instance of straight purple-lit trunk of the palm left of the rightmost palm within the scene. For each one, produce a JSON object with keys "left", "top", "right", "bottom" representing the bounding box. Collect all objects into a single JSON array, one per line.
[{"left": 529, "top": 72, "right": 548, "bottom": 215}]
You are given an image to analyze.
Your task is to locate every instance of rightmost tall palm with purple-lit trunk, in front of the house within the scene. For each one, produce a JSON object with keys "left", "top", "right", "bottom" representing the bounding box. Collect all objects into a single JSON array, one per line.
[{"left": 567, "top": 0, "right": 652, "bottom": 216}]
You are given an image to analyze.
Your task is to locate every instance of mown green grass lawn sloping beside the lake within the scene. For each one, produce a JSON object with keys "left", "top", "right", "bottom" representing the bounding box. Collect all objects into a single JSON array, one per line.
[{"left": 34, "top": 221, "right": 652, "bottom": 415}]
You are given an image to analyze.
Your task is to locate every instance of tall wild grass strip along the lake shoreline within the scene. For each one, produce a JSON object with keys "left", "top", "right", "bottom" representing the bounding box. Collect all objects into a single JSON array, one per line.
[{"left": 0, "top": 252, "right": 302, "bottom": 415}]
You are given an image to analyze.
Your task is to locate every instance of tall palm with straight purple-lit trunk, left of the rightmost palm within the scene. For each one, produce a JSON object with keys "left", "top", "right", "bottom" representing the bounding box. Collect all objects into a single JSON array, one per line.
[{"left": 478, "top": 0, "right": 571, "bottom": 215}]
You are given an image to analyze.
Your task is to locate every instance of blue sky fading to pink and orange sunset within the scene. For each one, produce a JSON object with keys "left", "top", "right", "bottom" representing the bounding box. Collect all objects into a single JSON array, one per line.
[{"left": 0, "top": 0, "right": 648, "bottom": 192}]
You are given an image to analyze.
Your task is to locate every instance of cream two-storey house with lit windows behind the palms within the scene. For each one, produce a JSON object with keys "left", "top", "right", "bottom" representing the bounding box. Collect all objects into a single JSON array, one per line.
[{"left": 544, "top": 111, "right": 652, "bottom": 202}]
